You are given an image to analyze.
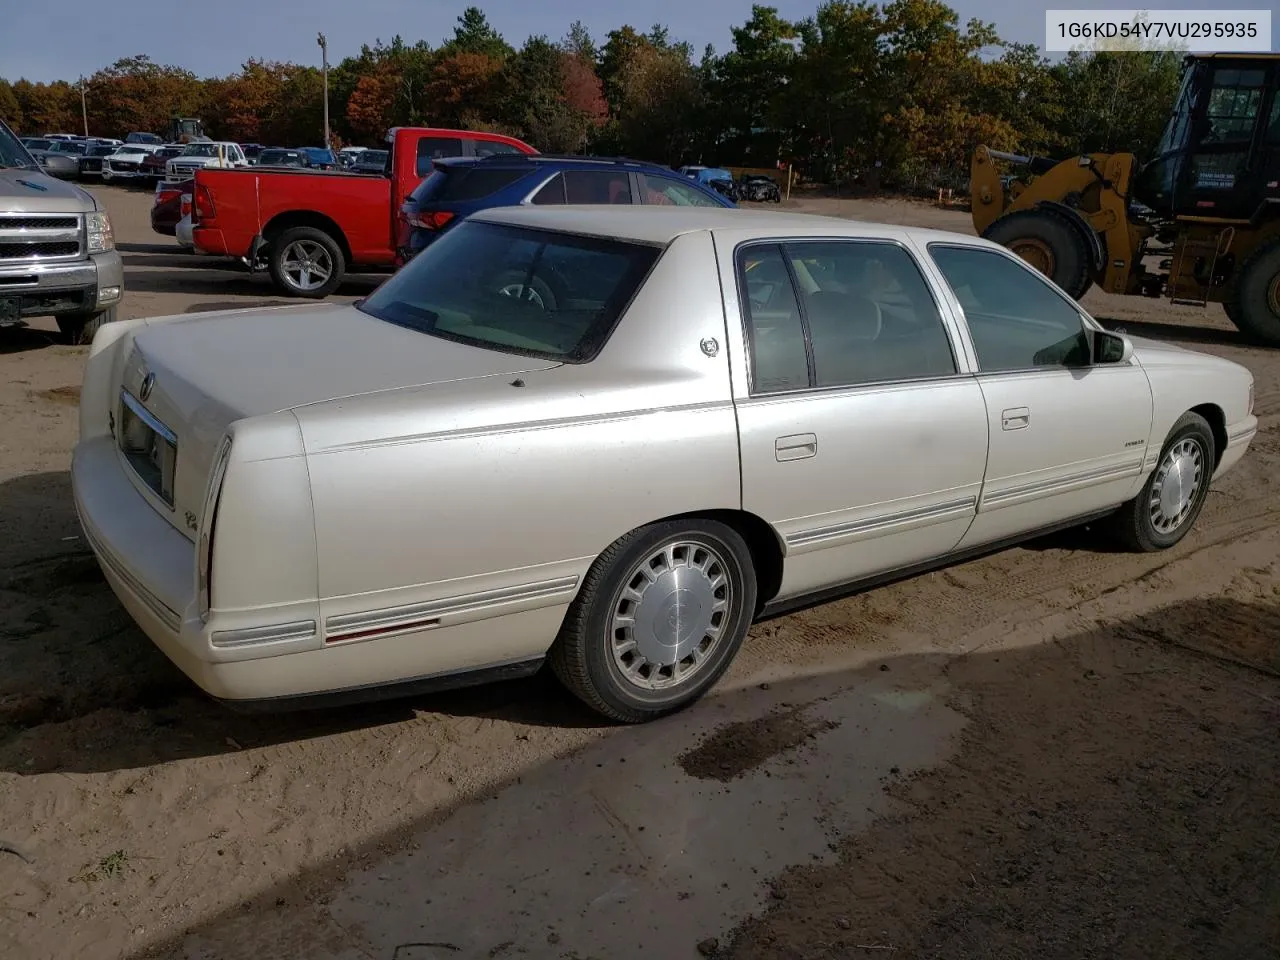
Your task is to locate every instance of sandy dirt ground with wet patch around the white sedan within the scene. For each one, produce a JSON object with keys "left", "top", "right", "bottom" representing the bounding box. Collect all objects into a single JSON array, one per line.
[{"left": 0, "top": 188, "right": 1280, "bottom": 960}]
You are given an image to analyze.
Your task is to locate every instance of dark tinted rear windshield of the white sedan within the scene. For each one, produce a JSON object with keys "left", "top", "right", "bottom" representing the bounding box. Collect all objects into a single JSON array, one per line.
[{"left": 360, "top": 220, "right": 662, "bottom": 364}]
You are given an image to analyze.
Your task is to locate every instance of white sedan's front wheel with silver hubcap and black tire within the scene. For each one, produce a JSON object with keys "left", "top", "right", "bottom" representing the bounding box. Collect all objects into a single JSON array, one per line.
[{"left": 1112, "top": 411, "right": 1217, "bottom": 553}]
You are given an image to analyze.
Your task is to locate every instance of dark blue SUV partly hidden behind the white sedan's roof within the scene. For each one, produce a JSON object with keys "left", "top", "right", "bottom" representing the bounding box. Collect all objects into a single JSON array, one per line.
[{"left": 397, "top": 154, "right": 737, "bottom": 261}]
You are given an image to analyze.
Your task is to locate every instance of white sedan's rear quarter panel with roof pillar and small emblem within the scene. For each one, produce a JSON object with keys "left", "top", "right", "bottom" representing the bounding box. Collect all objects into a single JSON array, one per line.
[{"left": 294, "top": 233, "right": 741, "bottom": 653}]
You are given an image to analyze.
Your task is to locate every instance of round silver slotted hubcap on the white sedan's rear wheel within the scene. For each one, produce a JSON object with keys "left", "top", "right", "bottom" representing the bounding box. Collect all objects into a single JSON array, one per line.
[{"left": 609, "top": 541, "right": 733, "bottom": 690}]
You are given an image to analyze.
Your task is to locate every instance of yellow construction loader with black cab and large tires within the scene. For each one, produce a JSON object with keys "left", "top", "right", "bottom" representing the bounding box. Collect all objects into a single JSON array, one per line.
[{"left": 969, "top": 54, "right": 1280, "bottom": 346}]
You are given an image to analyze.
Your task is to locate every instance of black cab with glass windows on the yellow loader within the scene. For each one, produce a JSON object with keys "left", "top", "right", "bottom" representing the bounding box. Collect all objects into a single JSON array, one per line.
[{"left": 1133, "top": 54, "right": 1280, "bottom": 221}]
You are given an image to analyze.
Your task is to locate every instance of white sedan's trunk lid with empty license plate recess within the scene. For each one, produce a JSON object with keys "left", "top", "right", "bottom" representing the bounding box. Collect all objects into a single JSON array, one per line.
[{"left": 113, "top": 305, "right": 557, "bottom": 539}]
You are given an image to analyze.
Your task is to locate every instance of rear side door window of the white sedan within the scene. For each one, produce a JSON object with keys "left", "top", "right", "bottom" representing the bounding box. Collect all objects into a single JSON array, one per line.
[{"left": 740, "top": 241, "right": 956, "bottom": 392}]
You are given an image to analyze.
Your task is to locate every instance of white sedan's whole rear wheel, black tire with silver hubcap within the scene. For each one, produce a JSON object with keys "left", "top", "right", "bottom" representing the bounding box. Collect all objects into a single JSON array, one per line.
[{"left": 550, "top": 520, "right": 756, "bottom": 723}]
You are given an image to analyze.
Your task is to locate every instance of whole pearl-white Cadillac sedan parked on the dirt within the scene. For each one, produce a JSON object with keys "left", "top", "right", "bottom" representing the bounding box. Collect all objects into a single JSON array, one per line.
[{"left": 64, "top": 206, "right": 1257, "bottom": 722}]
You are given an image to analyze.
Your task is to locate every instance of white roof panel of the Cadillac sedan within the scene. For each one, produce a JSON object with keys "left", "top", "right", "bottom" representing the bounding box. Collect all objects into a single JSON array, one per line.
[{"left": 470, "top": 204, "right": 998, "bottom": 247}]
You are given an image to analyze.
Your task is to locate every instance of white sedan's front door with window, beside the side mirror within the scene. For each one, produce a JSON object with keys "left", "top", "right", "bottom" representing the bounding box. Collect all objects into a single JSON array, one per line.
[{"left": 928, "top": 243, "right": 1158, "bottom": 548}]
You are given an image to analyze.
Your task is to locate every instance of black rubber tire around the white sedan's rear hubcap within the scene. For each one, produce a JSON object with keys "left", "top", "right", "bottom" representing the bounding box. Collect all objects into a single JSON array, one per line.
[{"left": 549, "top": 520, "right": 756, "bottom": 723}]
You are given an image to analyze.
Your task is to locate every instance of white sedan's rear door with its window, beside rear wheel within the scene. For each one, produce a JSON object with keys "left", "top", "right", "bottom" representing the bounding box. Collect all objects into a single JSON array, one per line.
[{"left": 717, "top": 237, "right": 987, "bottom": 599}]
